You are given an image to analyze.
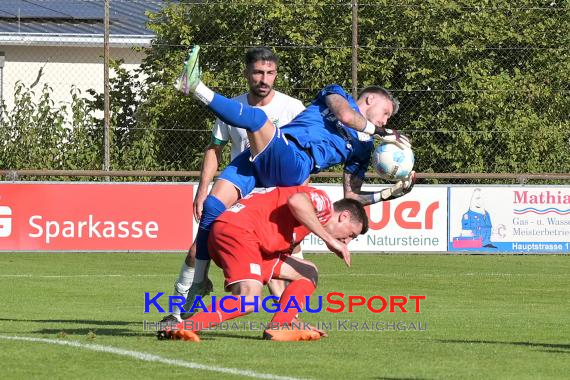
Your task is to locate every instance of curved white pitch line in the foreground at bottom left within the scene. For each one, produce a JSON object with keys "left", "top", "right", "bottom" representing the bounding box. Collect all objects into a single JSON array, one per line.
[{"left": 0, "top": 335, "right": 306, "bottom": 380}]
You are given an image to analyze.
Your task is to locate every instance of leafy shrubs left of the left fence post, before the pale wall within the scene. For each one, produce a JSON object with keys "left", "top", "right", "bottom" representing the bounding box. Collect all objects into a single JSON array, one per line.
[{"left": 0, "top": 82, "right": 101, "bottom": 169}]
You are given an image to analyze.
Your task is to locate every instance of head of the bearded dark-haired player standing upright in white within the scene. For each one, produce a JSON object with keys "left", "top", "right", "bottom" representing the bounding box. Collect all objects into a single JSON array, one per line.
[{"left": 243, "top": 47, "right": 279, "bottom": 101}]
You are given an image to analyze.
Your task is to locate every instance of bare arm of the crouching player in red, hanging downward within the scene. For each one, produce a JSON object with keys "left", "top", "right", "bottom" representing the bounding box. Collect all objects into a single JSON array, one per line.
[{"left": 287, "top": 193, "right": 350, "bottom": 266}]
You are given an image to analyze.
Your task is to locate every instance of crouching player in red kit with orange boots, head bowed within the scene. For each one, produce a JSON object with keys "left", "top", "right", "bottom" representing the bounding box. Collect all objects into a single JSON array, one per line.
[{"left": 159, "top": 186, "right": 368, "bottom": 341}]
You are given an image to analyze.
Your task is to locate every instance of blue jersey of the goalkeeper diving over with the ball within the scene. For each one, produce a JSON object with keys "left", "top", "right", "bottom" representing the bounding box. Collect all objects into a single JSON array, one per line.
[{"left": 281, "top": 84, "right": 374, "bottom": 178}]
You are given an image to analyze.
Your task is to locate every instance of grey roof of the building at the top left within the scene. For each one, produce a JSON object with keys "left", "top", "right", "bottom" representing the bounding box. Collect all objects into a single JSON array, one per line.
[{"left": 0, "top": 0, "right": 165, "bottom": 45}]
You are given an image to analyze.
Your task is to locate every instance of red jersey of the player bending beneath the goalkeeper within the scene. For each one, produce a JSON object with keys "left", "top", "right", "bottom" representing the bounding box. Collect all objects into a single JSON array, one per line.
[{"left": 214, "top": 186, "right": 333, "bottom": 254}]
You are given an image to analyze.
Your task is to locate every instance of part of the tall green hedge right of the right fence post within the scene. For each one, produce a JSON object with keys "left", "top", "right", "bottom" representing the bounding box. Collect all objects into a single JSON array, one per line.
[{"left": 359, "top": 0, "right": 570, "bottom": 173}]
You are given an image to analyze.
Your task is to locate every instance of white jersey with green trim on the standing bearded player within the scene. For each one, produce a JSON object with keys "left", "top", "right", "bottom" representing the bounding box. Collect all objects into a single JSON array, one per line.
[{"left": 212, "top": 91, "right": 305, "bottom": 160}]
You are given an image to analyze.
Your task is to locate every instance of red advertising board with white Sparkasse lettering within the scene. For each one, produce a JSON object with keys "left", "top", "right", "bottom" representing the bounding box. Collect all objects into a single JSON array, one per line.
[{"left": 0, "top": 183, "right": 193, "bottom": 251}]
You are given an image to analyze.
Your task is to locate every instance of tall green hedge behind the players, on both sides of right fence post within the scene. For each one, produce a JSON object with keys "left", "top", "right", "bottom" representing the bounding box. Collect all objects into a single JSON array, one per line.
[{"left": 139, "top": 0, "right": 570, "bottom": 172}]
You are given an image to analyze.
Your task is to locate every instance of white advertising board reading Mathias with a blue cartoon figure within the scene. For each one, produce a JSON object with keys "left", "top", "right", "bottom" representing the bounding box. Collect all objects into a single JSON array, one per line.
[{"left": 448, "top": 186, "right": 570, "bottom": 253}]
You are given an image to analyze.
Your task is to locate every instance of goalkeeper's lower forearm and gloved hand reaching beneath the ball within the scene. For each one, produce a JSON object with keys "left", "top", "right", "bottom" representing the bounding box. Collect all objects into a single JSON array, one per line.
[{"left": 343, "top": 171, "right": 416, "bottom": 206}]
